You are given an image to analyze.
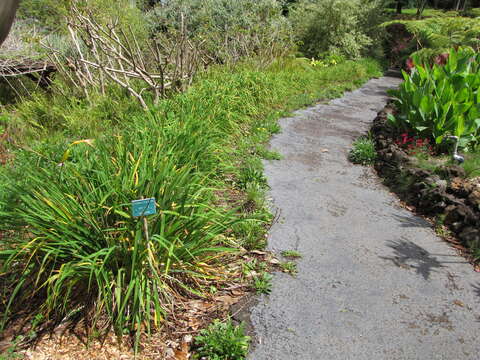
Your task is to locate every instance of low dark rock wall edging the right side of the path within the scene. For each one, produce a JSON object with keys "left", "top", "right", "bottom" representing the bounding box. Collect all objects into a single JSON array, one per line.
[{"left": 371, "top": 106, "right": 480, "bottom": 253}]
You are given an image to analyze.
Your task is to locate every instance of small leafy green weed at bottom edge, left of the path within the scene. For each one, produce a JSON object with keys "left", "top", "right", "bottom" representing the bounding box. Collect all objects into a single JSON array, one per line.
[{"left": 193, "top": 319, "right": 250, "bottom": 360}]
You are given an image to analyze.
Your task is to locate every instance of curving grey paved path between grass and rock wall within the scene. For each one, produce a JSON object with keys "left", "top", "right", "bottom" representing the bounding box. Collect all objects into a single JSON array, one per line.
[{"left": 249, "top": 77, "right": 480, "bottom": 360}]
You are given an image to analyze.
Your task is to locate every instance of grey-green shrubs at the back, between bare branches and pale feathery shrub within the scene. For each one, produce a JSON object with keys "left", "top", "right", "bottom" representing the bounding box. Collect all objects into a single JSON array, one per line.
[{"left": 148, "top": 0, "right": 292, "bottom": 63}]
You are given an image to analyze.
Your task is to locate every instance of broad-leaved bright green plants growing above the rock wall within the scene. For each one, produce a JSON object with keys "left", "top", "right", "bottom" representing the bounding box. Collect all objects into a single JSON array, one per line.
[{"left": 389, "top": 48, "right": 480, "bottom": 147}]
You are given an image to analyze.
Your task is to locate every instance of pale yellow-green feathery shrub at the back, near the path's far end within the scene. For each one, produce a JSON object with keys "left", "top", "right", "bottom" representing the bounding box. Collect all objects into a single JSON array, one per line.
[{"left": 290, "top": 0, "right": 383, "bottom": 59}]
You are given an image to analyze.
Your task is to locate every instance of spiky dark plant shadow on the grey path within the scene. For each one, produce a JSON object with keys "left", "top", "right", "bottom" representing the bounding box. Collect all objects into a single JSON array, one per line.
[{"left": 381, "top": 240, "right": 444, "bottom": 280}]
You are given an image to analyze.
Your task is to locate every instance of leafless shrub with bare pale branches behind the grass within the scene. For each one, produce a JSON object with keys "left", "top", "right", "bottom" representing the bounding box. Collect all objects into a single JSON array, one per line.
[{"left": 44, "top": 4, "right": 207, "bottom": 109}]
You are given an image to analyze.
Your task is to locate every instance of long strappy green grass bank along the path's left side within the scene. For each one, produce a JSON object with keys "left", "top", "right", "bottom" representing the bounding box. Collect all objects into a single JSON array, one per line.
[{"left": 0, "top": 59, "right": 380, "bottom": 344}]
